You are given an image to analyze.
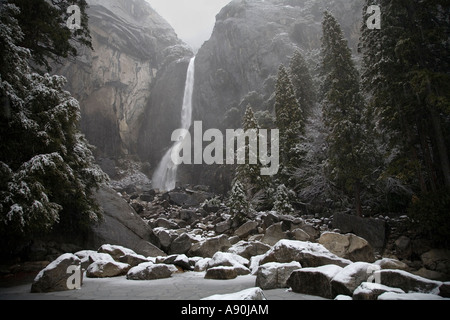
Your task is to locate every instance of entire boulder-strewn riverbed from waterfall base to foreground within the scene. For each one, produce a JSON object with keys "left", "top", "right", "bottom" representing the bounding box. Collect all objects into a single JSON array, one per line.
[{"left": 2, "top": 185, "right": 450, "bottom": 300}]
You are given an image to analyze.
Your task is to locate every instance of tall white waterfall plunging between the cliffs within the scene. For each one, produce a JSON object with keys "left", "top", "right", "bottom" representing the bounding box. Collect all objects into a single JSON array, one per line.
[{"left": 152, "top": 57, "right": 195, "bottom": 191}]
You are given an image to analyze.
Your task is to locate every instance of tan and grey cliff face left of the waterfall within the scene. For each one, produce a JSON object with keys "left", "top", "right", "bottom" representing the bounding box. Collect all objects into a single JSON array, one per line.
[{"left": 56, "top": 0, "right": 192, "bottom": 156}]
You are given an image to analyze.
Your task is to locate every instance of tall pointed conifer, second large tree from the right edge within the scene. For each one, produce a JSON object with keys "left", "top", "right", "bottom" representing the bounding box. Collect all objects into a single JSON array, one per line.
[{"left": 322, "top": 12, "right": 375, "bottom": 216}]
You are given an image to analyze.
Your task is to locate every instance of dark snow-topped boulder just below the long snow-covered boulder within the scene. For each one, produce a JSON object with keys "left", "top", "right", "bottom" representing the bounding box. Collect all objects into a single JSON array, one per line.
[{"left": 287, "top": 264, "right": 342, "bottom": 299}]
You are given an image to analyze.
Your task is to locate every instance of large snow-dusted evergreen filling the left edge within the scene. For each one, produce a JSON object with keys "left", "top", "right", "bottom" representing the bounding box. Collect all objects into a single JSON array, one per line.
[{"left": 0, "top": 4, "right": 105, "bottom": 252}]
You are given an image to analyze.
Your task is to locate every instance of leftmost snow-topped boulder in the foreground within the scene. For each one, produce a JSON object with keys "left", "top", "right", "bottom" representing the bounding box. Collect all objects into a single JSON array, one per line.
[{"left": 31, "top": 253, "right": 83, "bottom": 293}]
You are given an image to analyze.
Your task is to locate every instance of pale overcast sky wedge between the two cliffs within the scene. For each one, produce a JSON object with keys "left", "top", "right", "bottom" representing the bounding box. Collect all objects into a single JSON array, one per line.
[{"left": 147, "top": 0, "right": 231, "bottom": 51}]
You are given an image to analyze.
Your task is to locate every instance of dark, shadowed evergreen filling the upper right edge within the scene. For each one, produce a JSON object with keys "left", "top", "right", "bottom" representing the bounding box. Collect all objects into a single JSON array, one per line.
[{"left": 361, "top": 0, "right": 450, "bottom": 193}]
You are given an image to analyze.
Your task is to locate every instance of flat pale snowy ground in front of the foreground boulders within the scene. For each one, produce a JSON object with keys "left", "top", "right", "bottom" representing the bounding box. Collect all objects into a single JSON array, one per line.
[{"left": 0, "top": 272, "right": 322, "bottom": 301}]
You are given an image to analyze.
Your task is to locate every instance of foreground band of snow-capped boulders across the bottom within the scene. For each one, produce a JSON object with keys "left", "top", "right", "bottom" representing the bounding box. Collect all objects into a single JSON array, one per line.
[{"left": 31, "top": 242, "right": 450, "bottom": 300}]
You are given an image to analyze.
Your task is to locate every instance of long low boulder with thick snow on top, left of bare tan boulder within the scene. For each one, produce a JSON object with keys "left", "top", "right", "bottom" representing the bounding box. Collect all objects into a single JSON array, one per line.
[{"left": 261, "top": 240, "right": 352, "bottom": 268}]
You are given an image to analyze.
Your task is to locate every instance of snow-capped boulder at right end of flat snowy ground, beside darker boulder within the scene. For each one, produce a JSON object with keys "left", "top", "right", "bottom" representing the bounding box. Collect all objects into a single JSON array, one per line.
[{"left": 256, "top": 261, "right": 302, "bottom": 290}]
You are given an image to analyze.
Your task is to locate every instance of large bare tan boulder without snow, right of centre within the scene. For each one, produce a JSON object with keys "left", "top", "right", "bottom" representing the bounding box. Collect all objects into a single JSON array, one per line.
[{"left": 319, "top": 232, "right": 375, "bottom": 262}]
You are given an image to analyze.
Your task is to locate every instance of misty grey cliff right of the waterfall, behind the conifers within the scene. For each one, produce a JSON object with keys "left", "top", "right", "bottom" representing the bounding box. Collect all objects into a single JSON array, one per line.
[{"left": 181, "top": 0, "right": 362, "bottom": 190}]
